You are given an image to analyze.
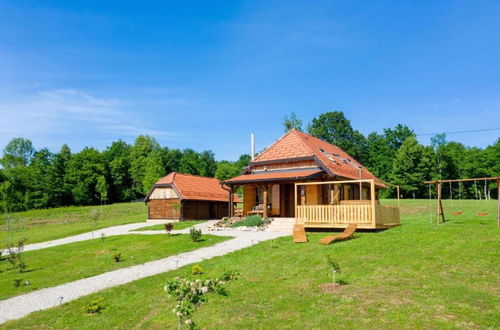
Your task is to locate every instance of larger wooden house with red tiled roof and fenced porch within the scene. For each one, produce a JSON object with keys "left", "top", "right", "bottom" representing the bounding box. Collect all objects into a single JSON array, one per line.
[{"left": 224, "top": 129, "right": 399, "bottom": 229}]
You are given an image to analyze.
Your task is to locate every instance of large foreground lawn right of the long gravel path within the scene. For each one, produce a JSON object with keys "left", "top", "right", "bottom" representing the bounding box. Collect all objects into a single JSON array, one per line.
[{"left": 3, "top": 200, "right": 500, "bottom": 329}]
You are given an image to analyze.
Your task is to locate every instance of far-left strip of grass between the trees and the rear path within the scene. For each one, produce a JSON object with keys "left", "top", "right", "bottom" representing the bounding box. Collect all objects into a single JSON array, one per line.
[{"left": 0, "top": 203, "right": 147, "bottom": 248}]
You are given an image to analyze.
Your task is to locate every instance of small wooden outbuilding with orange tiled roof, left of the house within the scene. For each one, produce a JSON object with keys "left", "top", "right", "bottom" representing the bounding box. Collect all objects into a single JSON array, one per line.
[{"left": 144, "top": 172, "right": 239, "bottom": 220}]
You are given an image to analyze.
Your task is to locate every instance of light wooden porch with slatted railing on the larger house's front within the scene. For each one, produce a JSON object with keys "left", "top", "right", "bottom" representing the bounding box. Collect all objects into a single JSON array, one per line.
[{"left": 295, "top": 180, "right": 399, "bottom": 229}]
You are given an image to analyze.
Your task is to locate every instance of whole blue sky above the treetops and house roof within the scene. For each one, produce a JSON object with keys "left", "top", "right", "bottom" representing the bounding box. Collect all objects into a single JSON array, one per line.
[{"left": 0, "top": 0, "right": 500, "bottom": 159}]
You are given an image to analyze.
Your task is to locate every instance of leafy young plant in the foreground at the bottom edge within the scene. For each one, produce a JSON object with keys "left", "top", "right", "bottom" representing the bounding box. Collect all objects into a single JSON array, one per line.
[{"left": 164, "top": 277, "right": 235, "bottom": 330}]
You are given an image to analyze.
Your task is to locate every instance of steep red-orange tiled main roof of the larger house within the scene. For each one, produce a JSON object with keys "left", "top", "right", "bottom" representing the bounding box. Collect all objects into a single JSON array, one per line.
[{"left": 232, "top": 129, "right": 385, "bottom": 187}]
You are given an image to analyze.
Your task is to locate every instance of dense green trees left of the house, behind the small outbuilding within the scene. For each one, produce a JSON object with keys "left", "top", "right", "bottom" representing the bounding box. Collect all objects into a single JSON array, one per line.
[{"left": 0, "top": 135, "right": 250, "bottom": 212}]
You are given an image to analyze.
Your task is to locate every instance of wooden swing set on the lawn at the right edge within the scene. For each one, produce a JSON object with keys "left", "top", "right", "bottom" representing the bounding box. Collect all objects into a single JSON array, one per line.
[{"left": 424, "top": 177, "right": 500, "bottom": 226}]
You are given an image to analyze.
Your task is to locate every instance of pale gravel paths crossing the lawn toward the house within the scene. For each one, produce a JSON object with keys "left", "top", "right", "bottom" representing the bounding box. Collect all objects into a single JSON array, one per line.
[{"left": 0, "top": 223, "right": 288, "bottom": 324}]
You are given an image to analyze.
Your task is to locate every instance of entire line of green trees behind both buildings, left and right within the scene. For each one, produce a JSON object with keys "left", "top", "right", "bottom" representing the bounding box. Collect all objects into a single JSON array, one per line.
[{"left": 0, "top": 111, "right": 500, "bottom": 212}]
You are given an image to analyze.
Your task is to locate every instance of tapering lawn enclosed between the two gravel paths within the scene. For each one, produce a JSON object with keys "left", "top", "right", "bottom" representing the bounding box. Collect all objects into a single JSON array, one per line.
[{"left": 0, "top": 234, "right": 227, "bottom": 299}]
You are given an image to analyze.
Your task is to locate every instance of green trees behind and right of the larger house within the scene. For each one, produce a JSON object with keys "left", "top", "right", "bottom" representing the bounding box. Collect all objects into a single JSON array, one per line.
[{"left": 283, "top": 111, "right": 500, "bottom": 199}]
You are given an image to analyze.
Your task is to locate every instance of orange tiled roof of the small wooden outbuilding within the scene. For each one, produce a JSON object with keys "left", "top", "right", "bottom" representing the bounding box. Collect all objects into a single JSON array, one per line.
[{"left": 150, "top": 172, "right": 240, "bottom": 203}]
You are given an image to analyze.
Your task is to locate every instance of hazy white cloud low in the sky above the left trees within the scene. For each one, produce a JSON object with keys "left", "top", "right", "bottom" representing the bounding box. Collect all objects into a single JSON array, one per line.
[{"left": 0, "top": 89, "right": 177, "bottom": 146}]
